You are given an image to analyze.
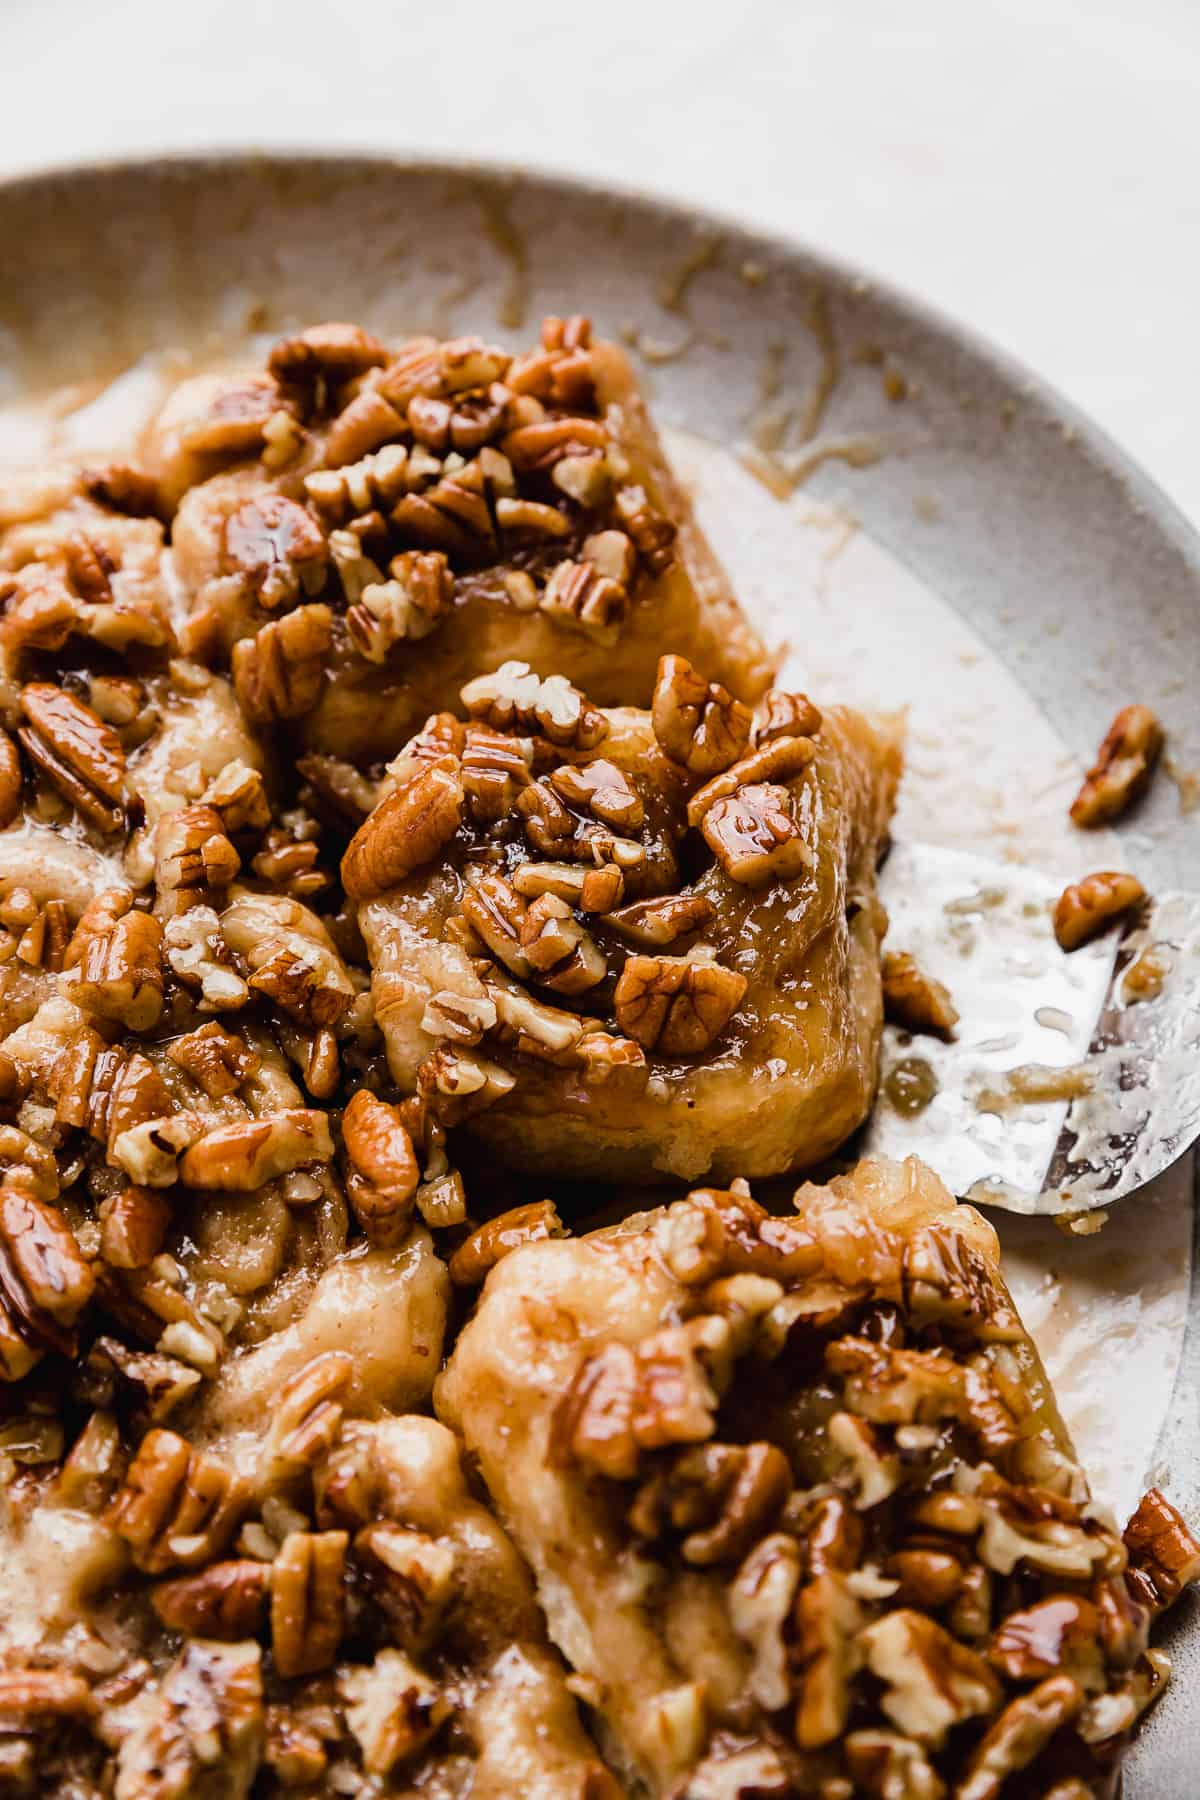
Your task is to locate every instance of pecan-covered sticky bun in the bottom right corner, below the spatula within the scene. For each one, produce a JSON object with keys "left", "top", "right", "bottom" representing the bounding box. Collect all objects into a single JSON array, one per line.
[{"left": 435, "top": 1161, "right": 1200, "bottom": 1800}]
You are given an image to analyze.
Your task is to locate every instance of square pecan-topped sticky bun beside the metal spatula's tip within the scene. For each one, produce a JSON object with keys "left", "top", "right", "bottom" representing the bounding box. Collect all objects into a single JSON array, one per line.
[{"left": 352, "top": 657, "right": 900, "bottom": 1181}]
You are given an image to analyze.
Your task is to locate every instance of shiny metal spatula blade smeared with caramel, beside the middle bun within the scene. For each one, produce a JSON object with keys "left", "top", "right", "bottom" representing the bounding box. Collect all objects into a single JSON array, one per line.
[{"left": 862, "top": 844, "right": 1200, "bottom": 1213}]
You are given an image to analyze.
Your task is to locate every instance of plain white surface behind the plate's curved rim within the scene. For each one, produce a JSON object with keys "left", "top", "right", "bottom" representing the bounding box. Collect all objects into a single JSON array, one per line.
[{"left": 0, "top": 0, "right": 1200, "bottom": 520}]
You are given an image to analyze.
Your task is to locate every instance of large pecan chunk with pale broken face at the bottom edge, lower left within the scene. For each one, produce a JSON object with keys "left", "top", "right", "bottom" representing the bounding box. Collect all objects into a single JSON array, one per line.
[{"left": 113, "top": 1638, "right": 263, "bottom": 1800}]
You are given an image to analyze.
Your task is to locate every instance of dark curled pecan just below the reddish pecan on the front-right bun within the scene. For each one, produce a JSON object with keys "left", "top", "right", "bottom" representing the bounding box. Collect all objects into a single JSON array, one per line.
[{"left": 630, "top": 1444, "right": 792, "bottom": 1568}]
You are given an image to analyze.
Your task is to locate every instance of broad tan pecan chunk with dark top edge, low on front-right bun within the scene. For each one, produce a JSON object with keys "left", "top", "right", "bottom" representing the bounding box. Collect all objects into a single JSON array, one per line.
[{"left": 858, "top": 1607, "right": 1000, "bottom": 1750}]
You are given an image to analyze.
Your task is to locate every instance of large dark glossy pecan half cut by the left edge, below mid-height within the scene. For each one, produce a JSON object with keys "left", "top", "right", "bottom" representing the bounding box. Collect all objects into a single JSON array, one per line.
[{"left": 0, "top": 1177, "right": 95, "bottom": 1381}]
